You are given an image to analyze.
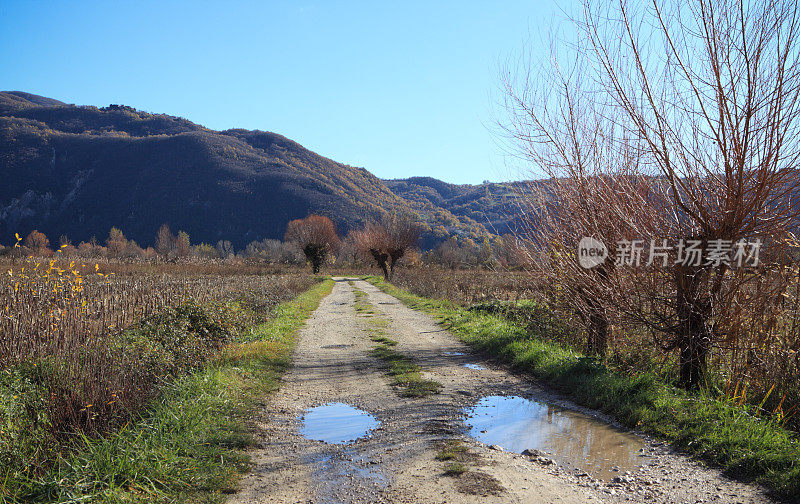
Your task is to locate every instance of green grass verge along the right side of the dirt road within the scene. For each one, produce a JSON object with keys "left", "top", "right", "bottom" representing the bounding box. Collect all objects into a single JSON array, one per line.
[{"left": 366, "top": 277, "right": 800, "bottom": 500}]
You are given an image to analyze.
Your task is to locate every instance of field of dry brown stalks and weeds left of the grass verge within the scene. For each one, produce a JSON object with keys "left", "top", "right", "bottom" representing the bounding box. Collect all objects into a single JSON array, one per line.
[{"left": 0, "top": 259, "right": 318, "bottom": 502}]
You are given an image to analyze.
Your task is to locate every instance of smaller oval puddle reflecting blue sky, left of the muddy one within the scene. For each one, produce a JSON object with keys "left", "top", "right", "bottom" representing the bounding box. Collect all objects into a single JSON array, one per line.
[{"left": 300, "top": 403, "right": 380, "bottom": 444}]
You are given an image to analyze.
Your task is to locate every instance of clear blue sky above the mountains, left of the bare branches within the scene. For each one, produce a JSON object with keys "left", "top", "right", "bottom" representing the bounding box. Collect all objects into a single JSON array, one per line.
[{"left": 0, "top": 0, "right": 565, "bottom": 183}]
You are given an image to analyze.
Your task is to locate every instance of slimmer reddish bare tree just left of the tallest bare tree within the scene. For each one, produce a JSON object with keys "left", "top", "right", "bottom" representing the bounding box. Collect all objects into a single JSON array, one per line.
[{"left": 503, "top": 40, "right": 657, "bottom": 355}]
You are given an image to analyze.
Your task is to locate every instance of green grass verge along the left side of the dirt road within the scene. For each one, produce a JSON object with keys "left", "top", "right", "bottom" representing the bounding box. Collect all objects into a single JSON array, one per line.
[{"left": 0, "top": 280, "right": 333, "bottom": 503}]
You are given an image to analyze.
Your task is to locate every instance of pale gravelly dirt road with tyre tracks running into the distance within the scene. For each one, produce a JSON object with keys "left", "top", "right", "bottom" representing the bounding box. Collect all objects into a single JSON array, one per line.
[{"left": 230, "top": 279, "right": 771, "bottom": 504}]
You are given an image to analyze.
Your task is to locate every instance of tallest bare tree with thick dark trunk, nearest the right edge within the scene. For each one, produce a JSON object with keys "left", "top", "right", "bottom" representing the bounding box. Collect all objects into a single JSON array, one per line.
[{"left": 504, "top": 0, "right": 800, "bottom": 387}]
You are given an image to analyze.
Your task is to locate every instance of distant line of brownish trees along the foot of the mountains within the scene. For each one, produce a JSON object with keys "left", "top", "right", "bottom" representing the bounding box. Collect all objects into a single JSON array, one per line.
[{"left": 0, "top": 214, "right": 530, "bottom": 272}]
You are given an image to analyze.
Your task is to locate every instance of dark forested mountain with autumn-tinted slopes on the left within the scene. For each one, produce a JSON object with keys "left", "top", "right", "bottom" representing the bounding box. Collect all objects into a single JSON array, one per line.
[{"left": 0, "top": 91, "right": 520, "bottom": 248}]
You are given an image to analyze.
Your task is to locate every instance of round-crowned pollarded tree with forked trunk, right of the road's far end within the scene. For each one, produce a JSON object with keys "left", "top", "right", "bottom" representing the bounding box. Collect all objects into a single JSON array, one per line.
[{"left": 355, "top": 214, "right": 419, "bottom": 280}]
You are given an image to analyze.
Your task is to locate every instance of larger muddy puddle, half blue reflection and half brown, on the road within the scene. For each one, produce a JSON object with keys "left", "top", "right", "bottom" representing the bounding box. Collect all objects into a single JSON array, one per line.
[{"left": 465, "top": 396, "right": 644, "bottom": 480}]
